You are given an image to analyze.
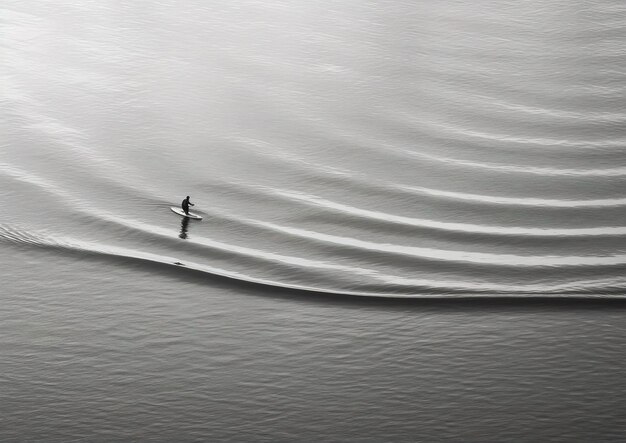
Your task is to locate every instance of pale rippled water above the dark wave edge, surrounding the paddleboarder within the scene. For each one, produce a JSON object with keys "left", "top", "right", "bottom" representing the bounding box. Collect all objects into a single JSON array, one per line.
[{"left": 0, "top": 1, "right": 626, "bottom": 297}]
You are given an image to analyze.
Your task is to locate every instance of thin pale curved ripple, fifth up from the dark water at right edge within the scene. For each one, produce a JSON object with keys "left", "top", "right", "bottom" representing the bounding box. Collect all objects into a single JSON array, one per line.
[{"left": 390, "top": 148, "right": 626, "bottom": 177}]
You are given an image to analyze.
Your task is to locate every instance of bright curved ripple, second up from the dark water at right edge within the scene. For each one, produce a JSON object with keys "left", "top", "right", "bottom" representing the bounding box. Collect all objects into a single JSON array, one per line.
[{"left": 251, "top": 221, "right": 626, "bottom": 267}]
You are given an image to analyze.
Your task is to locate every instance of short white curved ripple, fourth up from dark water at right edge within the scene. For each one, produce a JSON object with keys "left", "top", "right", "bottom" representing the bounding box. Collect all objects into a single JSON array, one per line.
[{"left": 394, "top": 185, "right": 626, "bottom": 208}]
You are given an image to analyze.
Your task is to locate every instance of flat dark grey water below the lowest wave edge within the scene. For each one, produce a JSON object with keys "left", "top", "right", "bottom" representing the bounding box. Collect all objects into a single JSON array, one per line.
[{"left": 0, "top": 248, "right": 626, "bottom": 442}]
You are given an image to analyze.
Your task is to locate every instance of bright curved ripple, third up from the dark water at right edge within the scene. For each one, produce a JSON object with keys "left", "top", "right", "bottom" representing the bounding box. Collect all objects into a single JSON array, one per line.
[{"left": 274, "top": 189, "right": 626, "bottom": 237}]
